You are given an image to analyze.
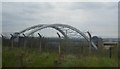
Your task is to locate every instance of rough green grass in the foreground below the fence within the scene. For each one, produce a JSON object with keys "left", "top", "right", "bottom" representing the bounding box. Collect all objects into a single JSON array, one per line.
[{"left": 2, "top": 47, "right": 118, "bottom": 67}]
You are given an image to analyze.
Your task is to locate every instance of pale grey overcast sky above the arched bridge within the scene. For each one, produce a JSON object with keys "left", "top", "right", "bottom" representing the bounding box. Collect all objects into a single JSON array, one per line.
[{"left": 2, "top": 2, "right": 118, "bottom": 37}]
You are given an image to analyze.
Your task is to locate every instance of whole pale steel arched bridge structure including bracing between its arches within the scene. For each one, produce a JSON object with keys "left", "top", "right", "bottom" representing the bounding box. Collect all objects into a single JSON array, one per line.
[{"left": 13, "top": 24, "right": 97, "bottom": 49}]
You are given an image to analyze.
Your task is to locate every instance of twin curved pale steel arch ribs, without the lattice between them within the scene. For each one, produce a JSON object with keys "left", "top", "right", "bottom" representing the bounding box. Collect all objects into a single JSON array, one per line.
[{"left": 13, "top": 24, "right": 97, "bottom": 49}]
